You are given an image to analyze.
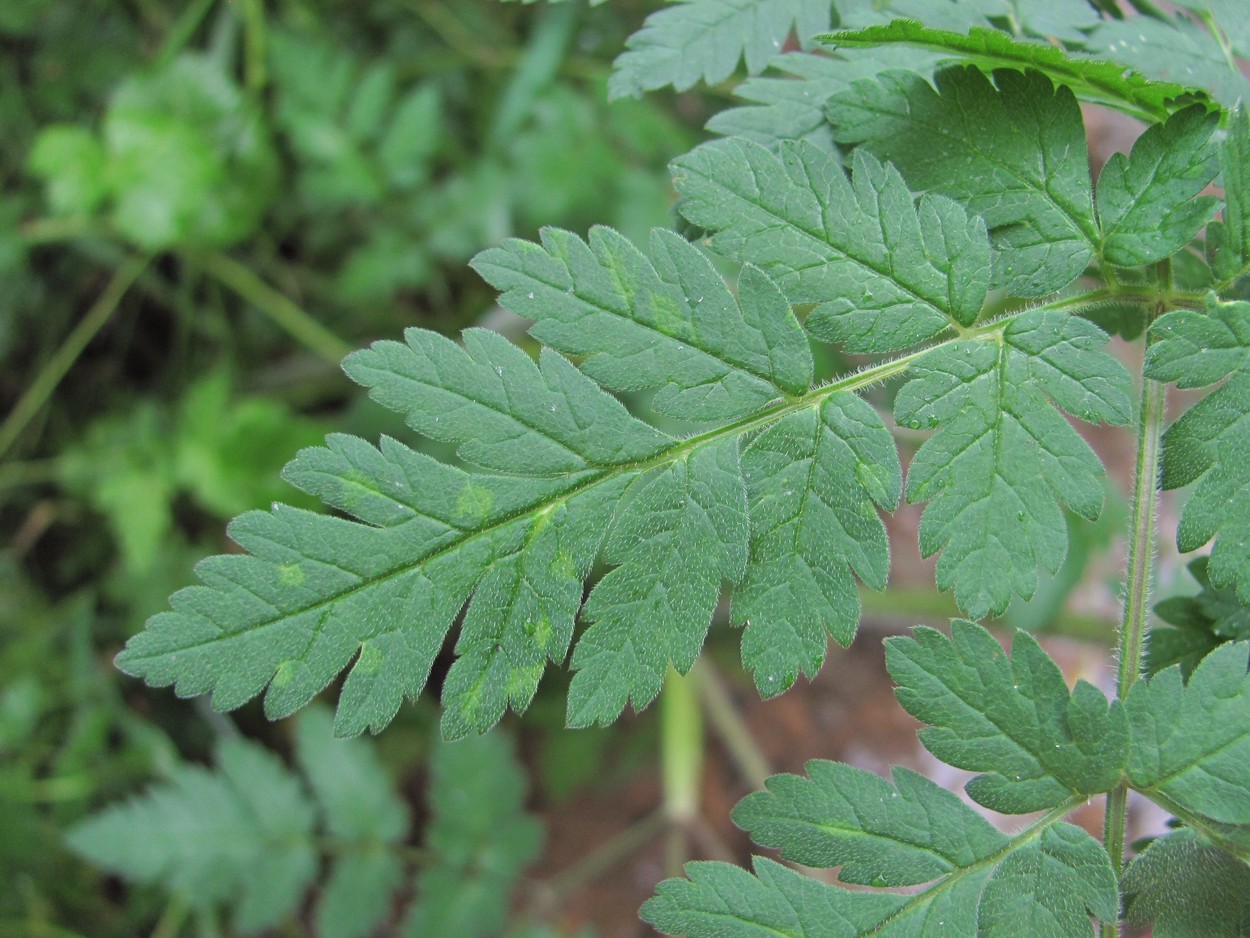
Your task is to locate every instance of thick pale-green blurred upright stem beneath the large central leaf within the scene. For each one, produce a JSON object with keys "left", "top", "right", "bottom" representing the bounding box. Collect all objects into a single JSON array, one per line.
[{"left": 660, "top": 665, "right": 704, "bottom": 872}]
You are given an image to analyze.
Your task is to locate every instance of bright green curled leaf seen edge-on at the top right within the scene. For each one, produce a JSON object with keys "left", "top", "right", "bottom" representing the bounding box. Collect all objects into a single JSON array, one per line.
[{"left": 818, "top": 19, "right": 1209, "bottom": 123}]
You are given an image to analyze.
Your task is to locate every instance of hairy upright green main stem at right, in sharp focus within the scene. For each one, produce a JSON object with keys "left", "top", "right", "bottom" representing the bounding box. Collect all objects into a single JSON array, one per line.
[{"left": 1103, "top": 335, "right": 1165, "bottom": 938}]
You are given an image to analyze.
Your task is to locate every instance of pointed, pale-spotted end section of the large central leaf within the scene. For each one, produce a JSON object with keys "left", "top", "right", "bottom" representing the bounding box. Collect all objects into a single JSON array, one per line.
[{"left": 118, "top": 435, "right": 575, "bottom": 734}]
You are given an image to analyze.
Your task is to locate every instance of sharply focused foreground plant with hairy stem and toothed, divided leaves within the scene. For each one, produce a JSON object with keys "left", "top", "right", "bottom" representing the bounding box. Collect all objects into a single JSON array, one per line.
[{"left": 107, "top": 0, "right": 1250, "bottom": 938}]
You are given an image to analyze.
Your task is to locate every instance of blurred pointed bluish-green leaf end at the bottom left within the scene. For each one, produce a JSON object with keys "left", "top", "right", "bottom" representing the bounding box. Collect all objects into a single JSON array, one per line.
[{"left": 68, "top": 739, "right": 318, "bottom": 932}]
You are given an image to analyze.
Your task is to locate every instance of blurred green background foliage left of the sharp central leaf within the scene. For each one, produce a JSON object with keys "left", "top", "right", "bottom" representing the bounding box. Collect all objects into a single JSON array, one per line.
[{"left": 0, "top": 0, "right": 695, "bottom": 938}]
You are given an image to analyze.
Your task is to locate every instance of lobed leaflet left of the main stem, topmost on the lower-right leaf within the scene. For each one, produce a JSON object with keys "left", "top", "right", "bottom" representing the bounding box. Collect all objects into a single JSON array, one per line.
[{"left": 886, "top": 619, "right": 1129, "bottom": 814}]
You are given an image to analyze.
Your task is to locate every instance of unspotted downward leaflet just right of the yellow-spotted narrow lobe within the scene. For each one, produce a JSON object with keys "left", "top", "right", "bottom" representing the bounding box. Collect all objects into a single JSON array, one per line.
[{"left": 569, "top": 439, "right": 748, "bottom": 727}]
